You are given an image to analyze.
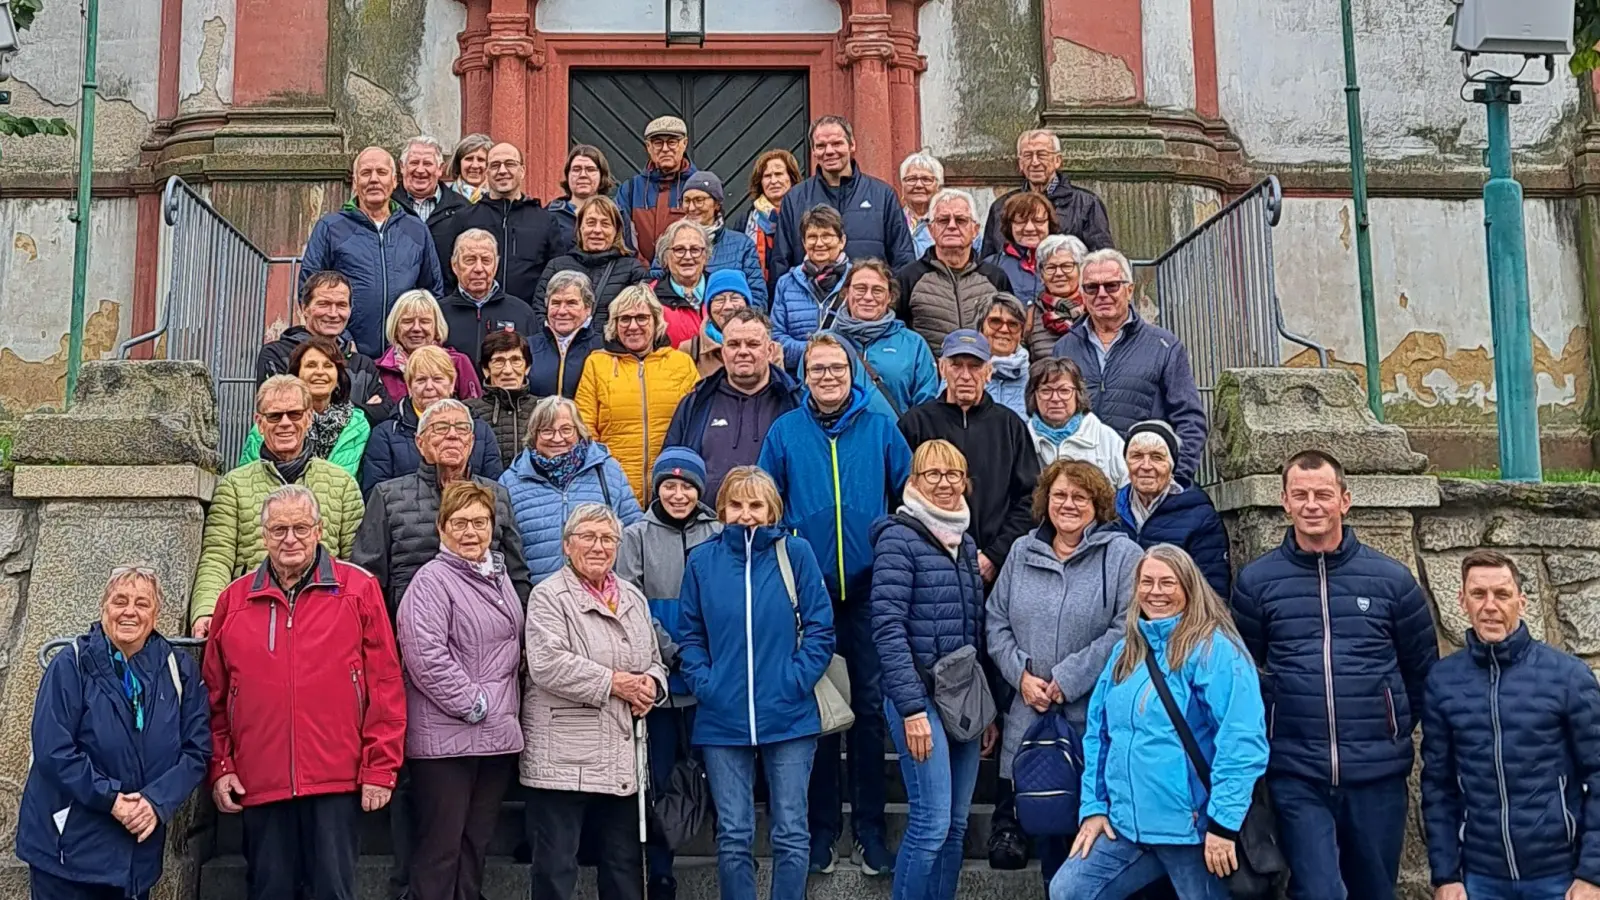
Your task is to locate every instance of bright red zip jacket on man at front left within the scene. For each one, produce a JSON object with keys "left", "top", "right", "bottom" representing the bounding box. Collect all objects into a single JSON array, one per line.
[{"left": 203, "top": 549, "right": 405, "bottom": 806}]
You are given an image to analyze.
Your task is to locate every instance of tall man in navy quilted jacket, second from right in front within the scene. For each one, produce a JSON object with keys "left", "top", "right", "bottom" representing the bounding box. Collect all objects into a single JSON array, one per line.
[{"left": 1234, "top": 450, "right": 1438, "bottom": 900}]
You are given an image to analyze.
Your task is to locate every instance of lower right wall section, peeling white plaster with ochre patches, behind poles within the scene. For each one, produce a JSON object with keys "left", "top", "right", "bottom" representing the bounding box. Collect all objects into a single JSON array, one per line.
[{"left": 1274, "top": 199, "right": 1589, "bottom": 424}]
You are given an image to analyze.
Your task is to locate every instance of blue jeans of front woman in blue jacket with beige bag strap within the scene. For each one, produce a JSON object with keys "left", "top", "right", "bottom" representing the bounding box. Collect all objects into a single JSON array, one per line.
[{"left": 701, "top": 738, "right": 816, "bottom": 900}]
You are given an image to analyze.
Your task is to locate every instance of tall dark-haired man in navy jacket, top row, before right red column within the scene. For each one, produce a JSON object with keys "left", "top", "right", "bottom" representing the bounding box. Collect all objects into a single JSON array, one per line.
[{"left": 768, "top": 115, "right": 917, "bottom": 283}]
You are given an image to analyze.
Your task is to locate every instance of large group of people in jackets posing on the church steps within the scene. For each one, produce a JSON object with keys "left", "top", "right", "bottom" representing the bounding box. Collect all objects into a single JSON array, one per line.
[{"left": 18, "top": 106, "right": 1600, "bottom": 900}]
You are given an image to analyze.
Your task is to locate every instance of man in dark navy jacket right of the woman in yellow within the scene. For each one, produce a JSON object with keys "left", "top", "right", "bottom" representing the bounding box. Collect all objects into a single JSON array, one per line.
[{"left": 662, "top": 306, "right": 800, "bottom": 498}]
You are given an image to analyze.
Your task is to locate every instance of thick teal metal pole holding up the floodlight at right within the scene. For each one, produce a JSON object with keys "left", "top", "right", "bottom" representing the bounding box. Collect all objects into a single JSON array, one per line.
[{"left": 1472, "top": 78, "right": 1544, "bottom": 482}]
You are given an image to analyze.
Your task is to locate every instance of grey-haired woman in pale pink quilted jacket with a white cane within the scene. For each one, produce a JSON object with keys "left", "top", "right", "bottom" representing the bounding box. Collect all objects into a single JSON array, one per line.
[{"left": 522, "top": 503, "right": 665, "bottom": 900}]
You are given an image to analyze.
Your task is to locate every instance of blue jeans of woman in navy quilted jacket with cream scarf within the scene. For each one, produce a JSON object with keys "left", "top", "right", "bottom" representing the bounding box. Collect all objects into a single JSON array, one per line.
[{"left": 883, "top": 698, "right": 982, "bottom": 900}]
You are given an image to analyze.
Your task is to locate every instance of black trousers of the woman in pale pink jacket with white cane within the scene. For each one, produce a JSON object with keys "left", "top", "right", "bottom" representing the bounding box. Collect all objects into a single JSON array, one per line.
[{"left": 528, "top": 790, "right": 645, "bottom": 900}]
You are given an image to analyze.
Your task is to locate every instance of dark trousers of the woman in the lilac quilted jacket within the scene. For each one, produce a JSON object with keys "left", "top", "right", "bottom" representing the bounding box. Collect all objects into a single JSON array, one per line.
[{"left": 408, "top": 754, "right": 517, "bottom": 900}]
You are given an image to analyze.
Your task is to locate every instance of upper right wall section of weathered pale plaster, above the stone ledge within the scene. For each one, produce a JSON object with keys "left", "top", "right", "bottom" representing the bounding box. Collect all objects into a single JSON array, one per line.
[{"left": 1209, "top": 0, "right": 1578, "bottom": 167}]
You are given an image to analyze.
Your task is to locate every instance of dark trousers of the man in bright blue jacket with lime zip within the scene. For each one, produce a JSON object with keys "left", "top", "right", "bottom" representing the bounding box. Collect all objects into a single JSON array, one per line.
[{"left": 810, "top": 594, "right": 888, "bottom": 842}]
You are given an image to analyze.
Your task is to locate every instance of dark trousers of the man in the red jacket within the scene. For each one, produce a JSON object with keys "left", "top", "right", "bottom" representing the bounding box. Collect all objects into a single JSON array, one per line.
[{"left": 240, "top": 793, "right": 362, "bottom": 900}]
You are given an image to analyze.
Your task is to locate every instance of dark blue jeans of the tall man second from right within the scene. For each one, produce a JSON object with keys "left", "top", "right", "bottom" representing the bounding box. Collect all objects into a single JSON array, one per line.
[{"left": 1267, "top": 775, "right": 1410, "bottom": 900}]
